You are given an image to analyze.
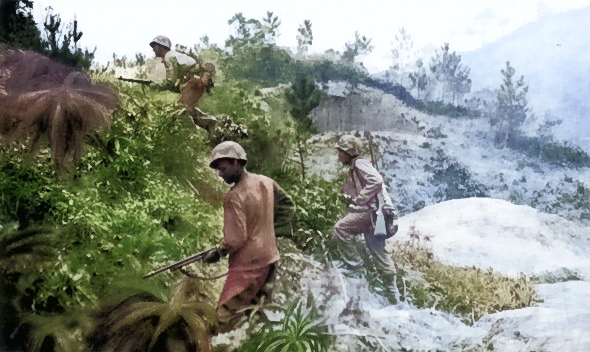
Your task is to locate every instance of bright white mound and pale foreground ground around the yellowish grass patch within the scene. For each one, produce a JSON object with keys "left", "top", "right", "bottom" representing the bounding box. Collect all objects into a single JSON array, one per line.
[{"left": 292, "top": 198, "right": 590, "bottom": 352}]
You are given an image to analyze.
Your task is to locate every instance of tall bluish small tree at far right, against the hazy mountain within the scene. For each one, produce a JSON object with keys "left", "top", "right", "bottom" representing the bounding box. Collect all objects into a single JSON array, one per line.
[{"left": 491, "top": 61, "right": 529, "bottom": 148}]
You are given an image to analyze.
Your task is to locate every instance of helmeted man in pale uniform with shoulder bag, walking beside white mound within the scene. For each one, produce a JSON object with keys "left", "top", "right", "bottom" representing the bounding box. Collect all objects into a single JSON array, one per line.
[{"left": 334, "top": 135, "right": 395, "bottom": 300}]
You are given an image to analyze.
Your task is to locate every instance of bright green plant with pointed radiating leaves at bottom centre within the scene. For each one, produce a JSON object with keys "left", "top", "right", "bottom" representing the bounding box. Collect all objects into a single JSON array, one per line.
[{"left": 239, "top": 300, "right": 333, "bottom": 352}]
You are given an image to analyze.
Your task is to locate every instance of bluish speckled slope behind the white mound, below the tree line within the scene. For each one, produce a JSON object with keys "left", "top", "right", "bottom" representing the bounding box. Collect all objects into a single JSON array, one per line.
[{"left": 311, "top": 87, "right": 590, "bottom": 225}]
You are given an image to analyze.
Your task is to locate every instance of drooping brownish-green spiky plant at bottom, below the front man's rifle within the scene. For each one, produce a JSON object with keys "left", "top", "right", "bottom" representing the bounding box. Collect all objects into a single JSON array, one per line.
[{"left": 88, "top": 278, "right": 216, "bottom": 352}]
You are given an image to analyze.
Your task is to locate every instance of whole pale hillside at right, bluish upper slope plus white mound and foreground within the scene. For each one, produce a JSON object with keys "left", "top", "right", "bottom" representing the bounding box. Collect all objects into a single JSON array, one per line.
[{"left": 278, "top": 87, "right": 590, "bottom": 351}]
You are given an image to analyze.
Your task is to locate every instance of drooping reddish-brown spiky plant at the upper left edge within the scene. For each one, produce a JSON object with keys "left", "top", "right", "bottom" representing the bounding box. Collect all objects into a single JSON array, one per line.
[{"left": 0, "top": 50, "right": 119, "bottom": 170}]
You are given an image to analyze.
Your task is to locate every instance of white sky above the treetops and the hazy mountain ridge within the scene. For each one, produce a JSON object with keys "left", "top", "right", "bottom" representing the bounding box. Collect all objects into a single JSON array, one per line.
[{"left": 33, "top": 0, "right": 590, "bottom": 73}]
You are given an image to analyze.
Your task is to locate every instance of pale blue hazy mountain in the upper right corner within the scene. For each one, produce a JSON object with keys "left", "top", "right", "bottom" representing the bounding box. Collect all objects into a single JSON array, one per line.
[{"left": 460, "top": 7, "right": 590, "bottom": 150}]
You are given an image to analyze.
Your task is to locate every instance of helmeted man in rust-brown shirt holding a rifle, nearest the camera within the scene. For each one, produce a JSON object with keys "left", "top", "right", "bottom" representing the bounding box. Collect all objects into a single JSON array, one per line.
[{"left": 205, "top": 141, "right": 295, "bottom": 331}]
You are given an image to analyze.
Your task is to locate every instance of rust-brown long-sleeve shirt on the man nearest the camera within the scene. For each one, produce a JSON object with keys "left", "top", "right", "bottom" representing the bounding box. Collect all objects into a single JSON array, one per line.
[{"left": 223, "top": 171, "right": 293, "bottom": 271}]
